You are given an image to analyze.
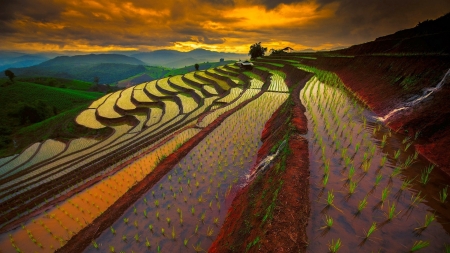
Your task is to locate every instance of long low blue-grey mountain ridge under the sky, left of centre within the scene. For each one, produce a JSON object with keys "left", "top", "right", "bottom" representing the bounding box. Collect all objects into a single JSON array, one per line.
[{"left": 39, "top": 54, "right": 145, "bottom": 67}]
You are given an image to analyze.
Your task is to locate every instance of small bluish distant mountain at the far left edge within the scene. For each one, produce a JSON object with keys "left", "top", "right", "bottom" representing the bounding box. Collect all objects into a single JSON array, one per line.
[{"left": 0, "top": 52, "right": 48, "bottom": 71}]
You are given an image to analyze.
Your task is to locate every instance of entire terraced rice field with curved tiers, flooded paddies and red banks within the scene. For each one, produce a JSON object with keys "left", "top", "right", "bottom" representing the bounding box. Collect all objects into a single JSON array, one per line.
[{"left": 0, "top": 54, "right": 450, "bottom": 252}]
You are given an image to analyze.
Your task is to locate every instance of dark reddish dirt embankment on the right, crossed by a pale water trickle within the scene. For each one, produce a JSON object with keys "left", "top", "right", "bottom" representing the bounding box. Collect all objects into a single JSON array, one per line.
[{"left": 296, "top": 55, "right": 450, "bottom": 175}]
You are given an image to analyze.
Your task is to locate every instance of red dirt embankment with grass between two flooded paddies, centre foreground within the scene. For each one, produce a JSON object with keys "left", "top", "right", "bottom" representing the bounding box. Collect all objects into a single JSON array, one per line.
[{"left": 209, "top": 69, "right": 311, "bottom": 252}]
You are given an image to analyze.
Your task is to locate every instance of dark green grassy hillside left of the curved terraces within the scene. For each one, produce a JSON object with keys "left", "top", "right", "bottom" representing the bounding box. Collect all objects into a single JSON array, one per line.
[{"left": 0, "top": 78, "right": 103, "bottom": 157}]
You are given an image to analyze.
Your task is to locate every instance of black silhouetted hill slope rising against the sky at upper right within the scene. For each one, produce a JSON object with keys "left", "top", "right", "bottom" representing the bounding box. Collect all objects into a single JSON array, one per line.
[{"left": 335, "top": 13, "right": 450, "bottom": 55}]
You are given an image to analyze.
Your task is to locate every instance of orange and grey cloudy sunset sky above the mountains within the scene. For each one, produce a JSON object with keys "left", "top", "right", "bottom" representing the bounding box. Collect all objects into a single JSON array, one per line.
[{"left": 0, "top": 0, "right": 450, "bottom": 53}]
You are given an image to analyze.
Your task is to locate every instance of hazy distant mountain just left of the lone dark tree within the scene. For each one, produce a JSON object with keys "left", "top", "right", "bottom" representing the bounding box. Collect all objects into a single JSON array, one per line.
[{"left": 132, "top": 49, "right": 248, "bottom": 68}]
